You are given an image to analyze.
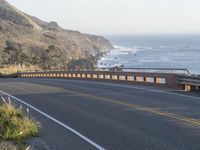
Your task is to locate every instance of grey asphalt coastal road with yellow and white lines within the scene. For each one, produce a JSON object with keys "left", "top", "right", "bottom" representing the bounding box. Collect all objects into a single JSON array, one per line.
[{"left": 0, "top": 79, "right": 200, "bottom": 150}]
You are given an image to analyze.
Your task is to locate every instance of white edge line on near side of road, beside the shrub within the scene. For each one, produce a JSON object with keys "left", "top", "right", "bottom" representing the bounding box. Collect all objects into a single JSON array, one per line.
[{"left": 0, "top": 90, "right": 105, "bottom": 150}]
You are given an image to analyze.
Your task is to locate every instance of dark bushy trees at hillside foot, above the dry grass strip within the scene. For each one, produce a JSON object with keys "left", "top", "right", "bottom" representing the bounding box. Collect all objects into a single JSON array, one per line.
[{"left": 0, "top": 41, "right": 68, "bottom": 69}]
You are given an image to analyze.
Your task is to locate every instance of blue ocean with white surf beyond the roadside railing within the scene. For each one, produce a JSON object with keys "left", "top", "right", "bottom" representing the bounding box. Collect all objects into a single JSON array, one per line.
[{"left": 98, "top": 35, "right": 200, "bottom": 74}]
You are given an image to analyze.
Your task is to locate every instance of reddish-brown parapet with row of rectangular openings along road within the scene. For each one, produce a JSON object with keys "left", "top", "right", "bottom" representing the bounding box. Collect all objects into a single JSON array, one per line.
[{"left": 18, "top": 68, "right": 180, "bottom": 88}]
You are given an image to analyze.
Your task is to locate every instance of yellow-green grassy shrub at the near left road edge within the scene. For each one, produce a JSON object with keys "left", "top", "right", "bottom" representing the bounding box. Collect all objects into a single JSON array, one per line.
[{"left": 0, "top": 98, "right": 40, "bottom": 141}]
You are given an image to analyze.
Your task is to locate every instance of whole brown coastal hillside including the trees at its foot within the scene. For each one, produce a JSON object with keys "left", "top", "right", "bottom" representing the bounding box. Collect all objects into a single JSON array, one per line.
[{"left": 0, "top": 0, "right": 112, "bottom": 70}]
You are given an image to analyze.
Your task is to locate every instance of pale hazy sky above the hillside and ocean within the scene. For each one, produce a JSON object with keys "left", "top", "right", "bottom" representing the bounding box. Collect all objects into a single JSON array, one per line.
[{"left": 8, "top": 0, "right": 200, "bottom": 34}]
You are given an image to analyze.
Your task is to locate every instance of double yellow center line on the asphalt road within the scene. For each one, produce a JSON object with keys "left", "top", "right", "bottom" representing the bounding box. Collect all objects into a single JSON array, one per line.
[{"left": 65, "top": 89, "right": 200, "bottom": 125}]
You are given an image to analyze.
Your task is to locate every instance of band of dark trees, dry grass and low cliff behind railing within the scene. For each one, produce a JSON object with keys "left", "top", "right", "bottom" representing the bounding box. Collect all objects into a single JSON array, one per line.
[{"left": 0, "top": 41, "right": 97, "bottom": 74}]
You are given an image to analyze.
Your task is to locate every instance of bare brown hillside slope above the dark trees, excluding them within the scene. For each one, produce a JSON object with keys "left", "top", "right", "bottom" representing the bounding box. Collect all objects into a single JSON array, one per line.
[{"left": 0, "top": 0, "right": 112, "bottom": 67}]
